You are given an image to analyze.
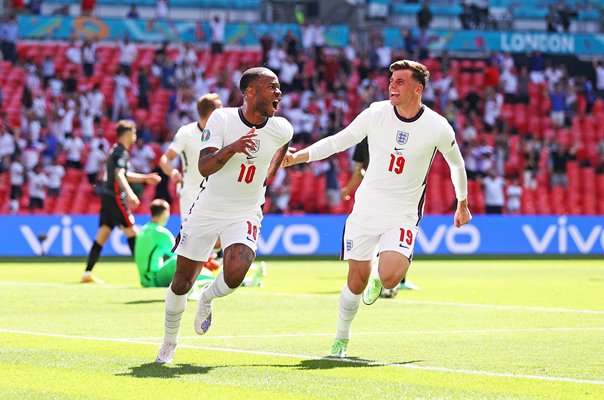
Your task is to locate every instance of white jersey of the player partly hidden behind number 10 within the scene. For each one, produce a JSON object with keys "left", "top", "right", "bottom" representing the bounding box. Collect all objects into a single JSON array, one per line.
[{"left": 168, "top": 122, "right": 203, "bottom": 197}]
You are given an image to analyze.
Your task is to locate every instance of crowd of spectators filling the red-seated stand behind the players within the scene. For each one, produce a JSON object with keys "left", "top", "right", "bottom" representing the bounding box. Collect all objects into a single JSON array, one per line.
[{"left": 0, "top": 13, "right": 604, "bottom": 213}]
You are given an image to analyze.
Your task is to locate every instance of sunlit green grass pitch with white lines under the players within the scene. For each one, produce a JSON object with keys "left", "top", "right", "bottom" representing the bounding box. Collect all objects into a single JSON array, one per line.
[{"left": 0, "top": 259, "right": 604, "bottom": 400}]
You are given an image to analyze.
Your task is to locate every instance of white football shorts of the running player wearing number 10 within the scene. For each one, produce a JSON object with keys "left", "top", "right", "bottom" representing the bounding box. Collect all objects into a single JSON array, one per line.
[{"left": 174, "top": 213, "right": 261, "bottom": 261}]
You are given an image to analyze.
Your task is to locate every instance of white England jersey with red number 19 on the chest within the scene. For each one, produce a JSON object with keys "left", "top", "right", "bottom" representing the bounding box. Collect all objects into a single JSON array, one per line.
[{"left": 332, "top": 100, "right": 459, "bottom": 223}]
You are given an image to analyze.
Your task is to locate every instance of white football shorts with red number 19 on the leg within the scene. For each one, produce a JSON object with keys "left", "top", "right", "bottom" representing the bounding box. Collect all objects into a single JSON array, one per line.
[{"left": 340, "top": 213, "right": 418, "bottom": 261}]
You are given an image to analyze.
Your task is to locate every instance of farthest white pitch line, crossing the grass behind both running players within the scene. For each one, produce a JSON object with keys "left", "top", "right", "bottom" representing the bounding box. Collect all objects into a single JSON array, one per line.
[{"left": 0, "top": 281, "right": 604, "bottom": 315}]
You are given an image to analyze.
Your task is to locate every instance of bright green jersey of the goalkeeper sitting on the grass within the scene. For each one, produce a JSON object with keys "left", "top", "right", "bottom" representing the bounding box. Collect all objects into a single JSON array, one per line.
[{"left": 134, "top": 221, "right": 174, "bottom": 286}]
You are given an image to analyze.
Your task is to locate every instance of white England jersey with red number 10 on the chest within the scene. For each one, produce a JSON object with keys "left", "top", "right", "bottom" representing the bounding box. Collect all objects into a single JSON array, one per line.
[{"left": 189, "top": 107, "right": 294, "bottom": 219}]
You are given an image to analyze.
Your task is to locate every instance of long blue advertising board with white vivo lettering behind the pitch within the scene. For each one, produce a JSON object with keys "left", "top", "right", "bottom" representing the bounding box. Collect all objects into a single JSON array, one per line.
[{"left": 0, "top": 215, "right": 604, "bottom": 257}]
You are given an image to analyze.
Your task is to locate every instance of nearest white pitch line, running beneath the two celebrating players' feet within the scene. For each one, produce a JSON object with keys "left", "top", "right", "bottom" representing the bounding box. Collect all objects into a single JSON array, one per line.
[{"left": 0, "top": 328, "right": 604, "bottom": 385}]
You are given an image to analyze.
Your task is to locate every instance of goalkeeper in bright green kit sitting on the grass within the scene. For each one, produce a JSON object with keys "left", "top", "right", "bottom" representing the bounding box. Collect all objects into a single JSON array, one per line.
[{"left": 134, "top": 199, "right": 214, "bottom": 287}]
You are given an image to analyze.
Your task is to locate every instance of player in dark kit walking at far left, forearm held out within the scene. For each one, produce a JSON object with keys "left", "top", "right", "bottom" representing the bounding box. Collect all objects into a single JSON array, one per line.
[{"left": 81, "top": 120, "right": 161, "bottom": 283}]
